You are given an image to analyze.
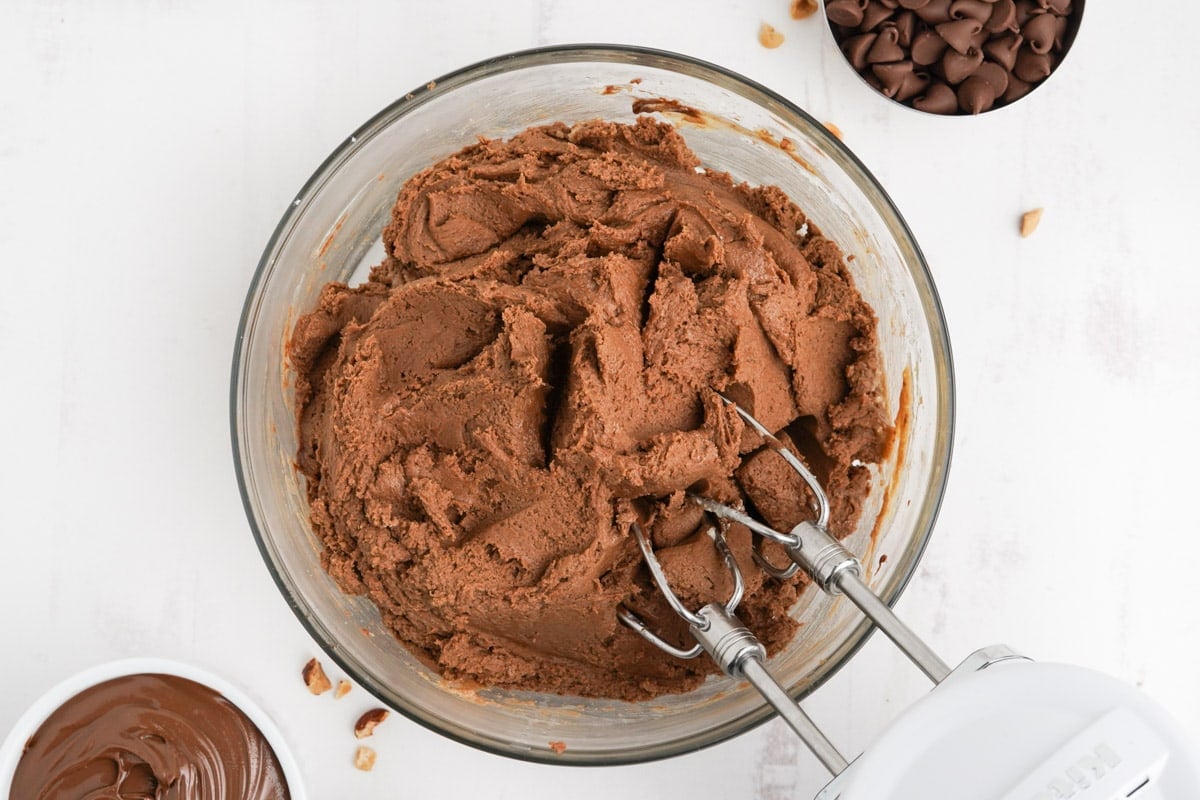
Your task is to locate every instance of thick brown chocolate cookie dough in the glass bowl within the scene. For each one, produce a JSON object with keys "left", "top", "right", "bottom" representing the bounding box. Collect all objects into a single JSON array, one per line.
[{"left": 289, "top": 116, "right": 890, "bottom": 699}]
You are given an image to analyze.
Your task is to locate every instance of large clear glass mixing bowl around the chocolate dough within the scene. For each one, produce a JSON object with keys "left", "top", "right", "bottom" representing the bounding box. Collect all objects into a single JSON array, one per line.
[{"left": 232, "top": 46, "right": 953, "bottom": 764}]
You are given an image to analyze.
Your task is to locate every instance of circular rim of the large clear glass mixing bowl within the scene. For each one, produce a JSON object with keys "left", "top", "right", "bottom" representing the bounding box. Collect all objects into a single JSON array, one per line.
[{"left": 229, "top": 43, "right": 955, "bottom": 766}]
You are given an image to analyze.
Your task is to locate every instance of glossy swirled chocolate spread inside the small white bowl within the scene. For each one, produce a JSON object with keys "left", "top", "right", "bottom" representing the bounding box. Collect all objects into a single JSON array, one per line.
[{"left": 8, "top": 674, "right": 289, "bottom": 800}]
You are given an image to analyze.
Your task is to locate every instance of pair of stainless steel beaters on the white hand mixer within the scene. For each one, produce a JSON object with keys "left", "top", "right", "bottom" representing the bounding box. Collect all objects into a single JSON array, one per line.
[{"left": 618, "top": 395, "right": 950, "bottom": 775}]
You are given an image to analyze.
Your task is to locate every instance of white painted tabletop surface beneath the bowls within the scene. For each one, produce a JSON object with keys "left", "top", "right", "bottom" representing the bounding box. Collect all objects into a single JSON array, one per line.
[{"left": 0, "top": 0, "right": 1200, "bottom": 800}]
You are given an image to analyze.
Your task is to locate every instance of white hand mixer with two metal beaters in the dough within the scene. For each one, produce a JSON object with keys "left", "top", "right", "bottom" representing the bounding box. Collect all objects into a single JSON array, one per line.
[{"left": 618, "top": 398, "right": 1200, "bottom": 800}]
